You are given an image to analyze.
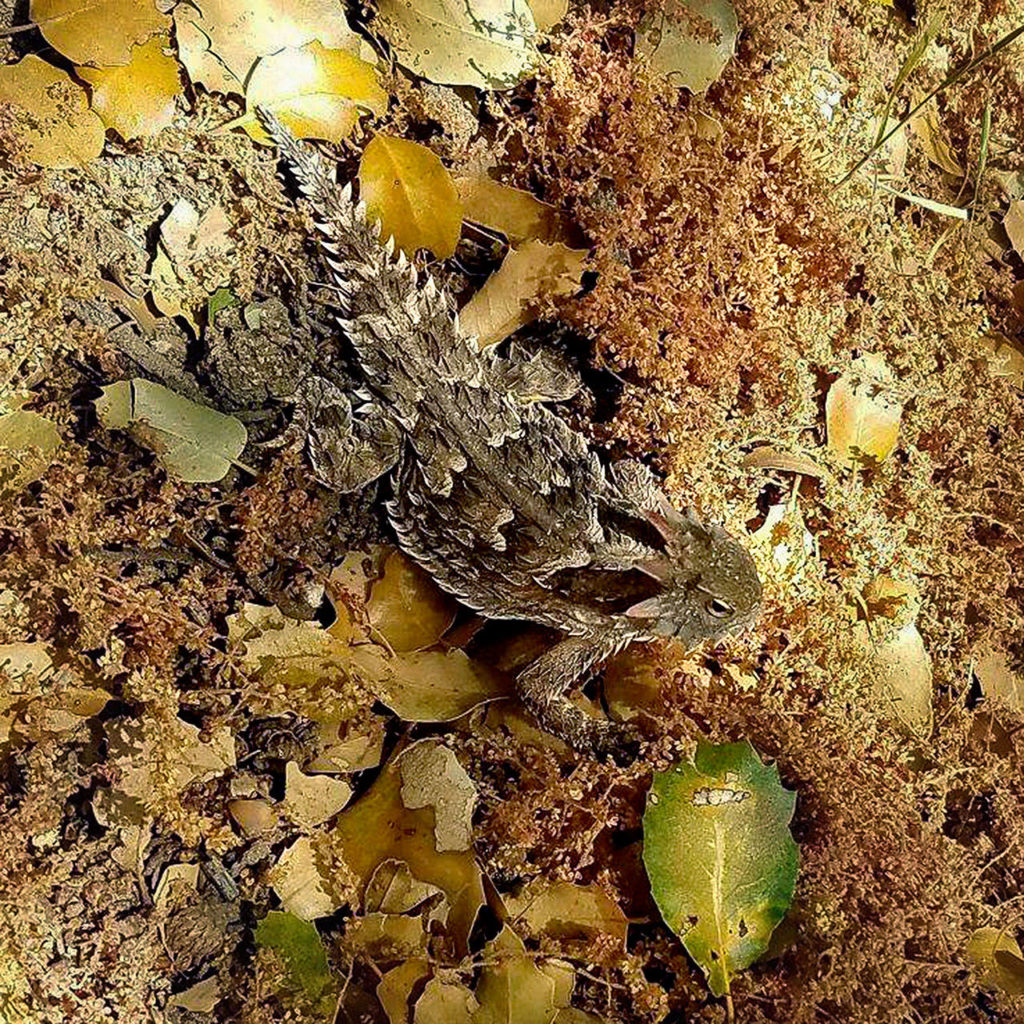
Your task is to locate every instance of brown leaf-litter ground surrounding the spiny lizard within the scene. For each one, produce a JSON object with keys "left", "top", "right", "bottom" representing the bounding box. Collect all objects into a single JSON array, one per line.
[{"left": 0, "top": 0, "right": 1024, "bottom": 1024}]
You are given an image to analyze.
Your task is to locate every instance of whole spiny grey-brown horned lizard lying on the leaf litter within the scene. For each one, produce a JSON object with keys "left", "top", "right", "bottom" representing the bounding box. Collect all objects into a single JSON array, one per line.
[{"left": 258, "top": 112, "right": 761, "bottom": 754}]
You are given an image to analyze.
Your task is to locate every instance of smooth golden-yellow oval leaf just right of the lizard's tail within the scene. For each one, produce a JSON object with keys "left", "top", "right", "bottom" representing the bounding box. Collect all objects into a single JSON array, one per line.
[{"left": 359, "top": 135, "right": 462, "bottom": 259}]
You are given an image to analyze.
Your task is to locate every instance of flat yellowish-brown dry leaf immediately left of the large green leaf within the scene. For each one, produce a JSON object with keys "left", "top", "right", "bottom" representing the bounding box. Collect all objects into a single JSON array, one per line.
[{"left": 504, "top": 878, "right": 628, "bottom": 952}]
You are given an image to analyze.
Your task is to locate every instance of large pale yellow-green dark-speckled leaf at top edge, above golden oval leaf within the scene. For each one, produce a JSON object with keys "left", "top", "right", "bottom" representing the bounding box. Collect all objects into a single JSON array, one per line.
[{"left": 373, "top": 0, "right": 540, "bottom": 89}]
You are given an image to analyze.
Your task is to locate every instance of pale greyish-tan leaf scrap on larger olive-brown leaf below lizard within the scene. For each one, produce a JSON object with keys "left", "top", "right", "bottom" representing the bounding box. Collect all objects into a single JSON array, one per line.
[{"left": 398, "top": 739, "right": 476, "bottom": 853}]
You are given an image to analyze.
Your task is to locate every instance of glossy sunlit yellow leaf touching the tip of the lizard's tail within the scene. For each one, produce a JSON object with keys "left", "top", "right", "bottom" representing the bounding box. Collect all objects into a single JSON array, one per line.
[{"left": 228, "top": 42, "right": 387, "bottom": 143}]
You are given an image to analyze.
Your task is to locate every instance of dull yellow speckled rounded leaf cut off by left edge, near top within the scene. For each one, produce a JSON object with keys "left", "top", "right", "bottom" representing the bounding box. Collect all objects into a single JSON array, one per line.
[{"left": 0, "top": 53, "right": 104, "bottom": 169}]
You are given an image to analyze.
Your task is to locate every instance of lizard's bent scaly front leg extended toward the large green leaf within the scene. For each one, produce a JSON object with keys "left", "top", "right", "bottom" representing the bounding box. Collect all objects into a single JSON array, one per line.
[{"left": 516, "top": 637, "right": 640, "bottom": 764}]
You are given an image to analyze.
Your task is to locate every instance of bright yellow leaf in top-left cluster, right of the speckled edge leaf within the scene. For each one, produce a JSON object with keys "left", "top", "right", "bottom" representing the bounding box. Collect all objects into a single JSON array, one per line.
[{"left": 76, "top": 36, "right": 181, "bottom": 139}]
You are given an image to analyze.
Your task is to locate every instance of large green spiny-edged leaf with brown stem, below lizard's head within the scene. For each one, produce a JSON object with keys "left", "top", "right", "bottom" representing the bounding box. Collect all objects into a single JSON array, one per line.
[{"left": 643, "top": 740, "right": 799, "bottom": 995}]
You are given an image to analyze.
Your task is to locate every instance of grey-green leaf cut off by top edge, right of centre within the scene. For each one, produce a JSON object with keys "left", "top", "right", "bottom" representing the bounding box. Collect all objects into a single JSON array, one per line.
[{"left": 636, "top": 0, "right": 739, "bottom": 93}]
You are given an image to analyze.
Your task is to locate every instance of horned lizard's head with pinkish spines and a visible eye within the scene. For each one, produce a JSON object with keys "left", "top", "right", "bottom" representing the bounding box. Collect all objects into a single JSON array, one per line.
[{"left": 626, "top": 502, "right": 761, "bottom": 646}]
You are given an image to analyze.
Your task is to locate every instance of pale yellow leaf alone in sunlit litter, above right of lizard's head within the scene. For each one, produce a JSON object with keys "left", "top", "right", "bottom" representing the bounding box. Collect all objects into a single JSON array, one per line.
[{"left": 825, "top": 353, "right": 903, "bottom": 463}]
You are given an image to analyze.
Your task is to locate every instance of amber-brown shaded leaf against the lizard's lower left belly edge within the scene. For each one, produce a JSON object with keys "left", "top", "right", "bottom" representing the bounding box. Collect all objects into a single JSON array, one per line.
[{"left": 367, "top": 551, "right": 457, "bottom": 651}]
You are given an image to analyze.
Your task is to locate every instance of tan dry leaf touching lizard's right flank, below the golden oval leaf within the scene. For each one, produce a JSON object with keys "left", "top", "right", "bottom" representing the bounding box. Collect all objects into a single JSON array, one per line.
[{"left": 459, "top": 241, "right": 587, "bottom": 348}]
